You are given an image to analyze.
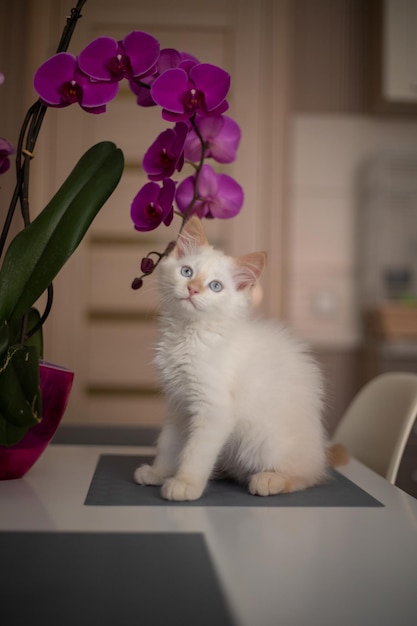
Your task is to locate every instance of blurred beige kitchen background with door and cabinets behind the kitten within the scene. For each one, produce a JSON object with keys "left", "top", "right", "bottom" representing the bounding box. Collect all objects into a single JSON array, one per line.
[{"left": 0, "top": 0, "right": 417, "bottom": 488}]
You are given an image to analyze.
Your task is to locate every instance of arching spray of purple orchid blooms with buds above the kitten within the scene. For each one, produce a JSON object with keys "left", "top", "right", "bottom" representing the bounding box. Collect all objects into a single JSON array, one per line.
[{"left": 34, "top": 22, "right": 243, "bottom": 289}]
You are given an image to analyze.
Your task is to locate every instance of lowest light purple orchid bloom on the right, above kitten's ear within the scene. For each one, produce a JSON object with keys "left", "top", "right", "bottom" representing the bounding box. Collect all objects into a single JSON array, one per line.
[{"left": 175, "top": 165, "right": 244, "bottom": 219}]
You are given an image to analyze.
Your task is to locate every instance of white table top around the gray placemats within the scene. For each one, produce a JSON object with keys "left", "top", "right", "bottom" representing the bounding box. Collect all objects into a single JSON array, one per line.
[{"left": 0, "top": 438, "right": 417, "bottom": 626}]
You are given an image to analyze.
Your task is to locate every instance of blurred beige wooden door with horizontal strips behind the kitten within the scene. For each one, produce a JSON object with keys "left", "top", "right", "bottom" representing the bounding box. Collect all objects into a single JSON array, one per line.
[{"left": 23, "top": 0, "right": 288, "bottom": 425}]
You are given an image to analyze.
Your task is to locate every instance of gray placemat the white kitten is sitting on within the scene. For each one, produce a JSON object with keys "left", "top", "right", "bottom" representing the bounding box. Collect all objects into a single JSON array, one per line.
[{"left": 85, "top": 454, "right": 384, "bottom": 507}]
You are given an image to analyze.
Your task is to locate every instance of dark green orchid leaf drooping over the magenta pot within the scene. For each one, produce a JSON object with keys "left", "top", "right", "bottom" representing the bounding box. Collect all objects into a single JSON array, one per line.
[{"left": 0, "top": 345, "right": 42, "bottom": 446}]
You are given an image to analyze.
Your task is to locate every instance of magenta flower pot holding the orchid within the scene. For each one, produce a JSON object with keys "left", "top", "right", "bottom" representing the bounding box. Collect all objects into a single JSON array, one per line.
[{"left": 0, "top": 361, "right": 74, "bottom": 480}]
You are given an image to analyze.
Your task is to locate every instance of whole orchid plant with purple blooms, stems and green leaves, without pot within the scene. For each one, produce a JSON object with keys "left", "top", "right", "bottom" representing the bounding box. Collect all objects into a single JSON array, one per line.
[{"left": 0, "top": 0, "right": 243, "bottom": 445}]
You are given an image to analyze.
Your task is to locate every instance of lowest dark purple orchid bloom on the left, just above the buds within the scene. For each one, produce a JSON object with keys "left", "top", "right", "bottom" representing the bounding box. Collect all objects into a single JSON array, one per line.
[{"left": 130, "top": 178, "right": 175, "bottom": 232}]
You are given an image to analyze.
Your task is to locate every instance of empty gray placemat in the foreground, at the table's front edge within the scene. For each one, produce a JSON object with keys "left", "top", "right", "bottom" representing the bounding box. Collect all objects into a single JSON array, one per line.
[{"left": 0, "top": 532, "right": 234, "bottom": 626}]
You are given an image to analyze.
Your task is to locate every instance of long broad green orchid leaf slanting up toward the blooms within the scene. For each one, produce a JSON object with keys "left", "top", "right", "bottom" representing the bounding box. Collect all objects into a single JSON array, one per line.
[{"left": 0, "top": 141, "right": 124, "bottom": 323}]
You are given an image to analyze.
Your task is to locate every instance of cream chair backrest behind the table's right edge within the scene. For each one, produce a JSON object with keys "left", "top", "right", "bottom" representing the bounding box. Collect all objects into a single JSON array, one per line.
[{"left": 333, "top": 372, "right": 417, "bottom": 484}]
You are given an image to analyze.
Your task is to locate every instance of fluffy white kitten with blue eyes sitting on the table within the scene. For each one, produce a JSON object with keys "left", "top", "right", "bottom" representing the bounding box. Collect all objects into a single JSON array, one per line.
[{"left": 135, "top": 218, "right": 327, "bottom": 500}]
